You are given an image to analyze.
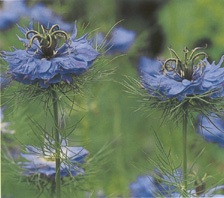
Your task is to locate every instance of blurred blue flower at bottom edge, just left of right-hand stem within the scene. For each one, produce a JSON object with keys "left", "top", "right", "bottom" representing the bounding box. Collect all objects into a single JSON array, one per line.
[{"left": 130, "top": 170, "right": 182, "bottom": 197}]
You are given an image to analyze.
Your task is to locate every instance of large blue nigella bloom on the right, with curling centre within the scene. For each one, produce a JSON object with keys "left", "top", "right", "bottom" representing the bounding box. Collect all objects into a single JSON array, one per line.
[{"left": 139, "top": 48, "right": 224, "bottom": 101}]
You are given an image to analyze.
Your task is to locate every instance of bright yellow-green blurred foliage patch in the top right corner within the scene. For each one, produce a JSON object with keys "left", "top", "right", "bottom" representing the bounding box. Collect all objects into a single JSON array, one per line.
[{"left": 159, "top": 0, "right": 224, "bottom": 61}]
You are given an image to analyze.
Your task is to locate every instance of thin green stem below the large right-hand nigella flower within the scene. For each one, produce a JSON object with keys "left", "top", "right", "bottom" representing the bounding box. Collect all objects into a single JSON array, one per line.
[{"left": 183, "top": 111, "right": 188, "bottom": 190}]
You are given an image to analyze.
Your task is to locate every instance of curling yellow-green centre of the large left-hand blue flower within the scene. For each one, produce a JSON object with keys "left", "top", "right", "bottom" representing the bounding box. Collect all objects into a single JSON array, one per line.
[{"left": 25, "top": 25, "right": 68, "bottom": 58}]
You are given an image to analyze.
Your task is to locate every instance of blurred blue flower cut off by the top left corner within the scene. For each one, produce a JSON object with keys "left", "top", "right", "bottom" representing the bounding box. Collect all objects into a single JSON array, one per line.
[{"left": 0, "top": 0, "right": 27, "bottom": 30}]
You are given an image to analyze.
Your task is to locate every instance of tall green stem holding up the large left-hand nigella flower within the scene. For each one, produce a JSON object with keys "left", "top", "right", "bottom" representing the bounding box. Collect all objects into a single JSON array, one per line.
[{"left": 52, "top": 90, "right": 61, "bottom": 198}]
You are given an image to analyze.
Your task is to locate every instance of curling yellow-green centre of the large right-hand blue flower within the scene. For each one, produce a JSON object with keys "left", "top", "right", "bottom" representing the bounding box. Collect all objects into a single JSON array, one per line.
[{"left": 162, "top": 46, "right": 208, "bottom": 80}]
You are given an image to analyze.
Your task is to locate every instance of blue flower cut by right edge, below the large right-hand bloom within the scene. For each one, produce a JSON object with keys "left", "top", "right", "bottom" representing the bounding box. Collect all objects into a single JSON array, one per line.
[{"left": 198, "top": 114, "right": 224, "bottom": 147}]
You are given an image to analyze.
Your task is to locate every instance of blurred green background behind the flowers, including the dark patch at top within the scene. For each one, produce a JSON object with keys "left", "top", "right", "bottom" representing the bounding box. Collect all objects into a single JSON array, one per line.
[{"left": 0, "top": 0, "right": 224, "bottom": 198}]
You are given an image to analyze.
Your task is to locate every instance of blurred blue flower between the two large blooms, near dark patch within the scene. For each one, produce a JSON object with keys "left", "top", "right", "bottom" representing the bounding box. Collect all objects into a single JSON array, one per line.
[{"left": 96, "top": 27, "right": 136, "bottom": 55}]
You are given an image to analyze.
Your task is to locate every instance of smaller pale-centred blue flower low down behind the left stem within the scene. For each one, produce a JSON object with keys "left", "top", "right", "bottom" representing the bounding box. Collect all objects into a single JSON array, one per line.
[{"left": 19, "top": 140, "right": 88, "bottom": 178}]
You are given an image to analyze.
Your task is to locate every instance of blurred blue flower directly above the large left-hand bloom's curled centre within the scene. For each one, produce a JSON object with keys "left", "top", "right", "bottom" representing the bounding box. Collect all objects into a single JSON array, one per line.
[{"left": 28, "top": 3, "right": 72, "bottom": 32}]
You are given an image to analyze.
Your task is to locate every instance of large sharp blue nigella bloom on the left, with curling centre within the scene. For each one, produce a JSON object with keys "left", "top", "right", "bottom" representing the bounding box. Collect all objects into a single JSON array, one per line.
[{"left": 2, "top": 21, "right": 99, "bottom": 88}]
